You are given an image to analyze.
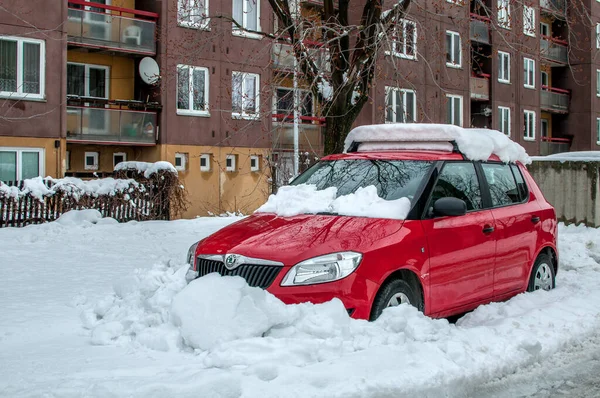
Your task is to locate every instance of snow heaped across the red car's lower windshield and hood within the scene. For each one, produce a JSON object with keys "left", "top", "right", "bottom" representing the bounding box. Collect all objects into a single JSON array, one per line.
[{"left": 256, "top": 184, "right": 411, "bottom": 220}]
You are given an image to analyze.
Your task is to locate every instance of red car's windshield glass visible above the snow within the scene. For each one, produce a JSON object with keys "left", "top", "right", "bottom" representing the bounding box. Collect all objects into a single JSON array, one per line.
[{"left": 290, "top": 159, "right": 433, "bottom": 201}]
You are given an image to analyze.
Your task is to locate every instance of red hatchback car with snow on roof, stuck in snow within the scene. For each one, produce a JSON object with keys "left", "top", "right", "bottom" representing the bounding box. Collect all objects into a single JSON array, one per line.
[{"left": 188, "top": 125, "right": 558, "bottom": 320}]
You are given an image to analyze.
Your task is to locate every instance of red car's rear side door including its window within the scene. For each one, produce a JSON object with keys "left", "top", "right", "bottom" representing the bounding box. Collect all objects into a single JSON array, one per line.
[{"left": 481, "top": 162, "right": 540, "bottom": 296}]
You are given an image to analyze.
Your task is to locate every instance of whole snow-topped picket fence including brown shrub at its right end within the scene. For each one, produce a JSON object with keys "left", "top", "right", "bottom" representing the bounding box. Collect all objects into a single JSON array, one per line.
[{"left": 0, "top": 164, "right": 186, "bottom": 228}]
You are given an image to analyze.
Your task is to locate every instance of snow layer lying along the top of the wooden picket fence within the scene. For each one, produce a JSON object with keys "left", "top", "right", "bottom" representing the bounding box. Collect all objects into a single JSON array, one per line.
[{"left": 0, "top": 177, "right": 144, "bottom": 201}]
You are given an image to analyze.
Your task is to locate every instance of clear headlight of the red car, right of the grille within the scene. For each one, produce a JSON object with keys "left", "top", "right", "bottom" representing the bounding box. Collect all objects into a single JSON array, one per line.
[{"left": 281, "top": 252, "right": 362, "bottom": 286}]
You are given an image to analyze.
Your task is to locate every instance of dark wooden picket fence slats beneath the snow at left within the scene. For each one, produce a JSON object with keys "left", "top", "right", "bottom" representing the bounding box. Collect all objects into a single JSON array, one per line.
[{"left": 0, "top": 180, "right": 170, "bottom": 228}]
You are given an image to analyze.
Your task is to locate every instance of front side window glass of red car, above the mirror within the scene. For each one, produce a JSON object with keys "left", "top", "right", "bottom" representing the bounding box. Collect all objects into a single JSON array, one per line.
[{"left": 430, "top": 162, "right": 482, "bottom": 211}]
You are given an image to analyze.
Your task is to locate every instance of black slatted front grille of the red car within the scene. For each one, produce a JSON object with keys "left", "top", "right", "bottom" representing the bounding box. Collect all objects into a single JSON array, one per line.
[{"left": 196, "top": 258, "right": 281, "bottom": 289}]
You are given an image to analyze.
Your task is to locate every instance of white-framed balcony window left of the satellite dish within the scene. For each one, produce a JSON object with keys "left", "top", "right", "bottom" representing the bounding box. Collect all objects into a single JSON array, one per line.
[{"left": 67, "top": 62, "right": 109, "bottom": 98}]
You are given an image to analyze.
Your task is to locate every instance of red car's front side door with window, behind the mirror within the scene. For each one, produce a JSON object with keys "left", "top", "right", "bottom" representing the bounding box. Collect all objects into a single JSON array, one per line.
[{"left": 422, "top": 161, "right": 496, "bottom": 316}]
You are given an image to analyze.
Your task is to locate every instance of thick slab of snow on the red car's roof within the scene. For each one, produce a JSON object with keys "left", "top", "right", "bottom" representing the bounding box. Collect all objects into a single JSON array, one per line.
[{"left": 344, "top": 123, "right": 531, "bottom": 164}]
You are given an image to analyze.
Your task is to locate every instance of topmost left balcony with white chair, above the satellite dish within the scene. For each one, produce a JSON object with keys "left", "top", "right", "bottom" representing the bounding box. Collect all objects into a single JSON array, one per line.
[{"left": 67, "top": 0, "right": 158, "bottom": 55}]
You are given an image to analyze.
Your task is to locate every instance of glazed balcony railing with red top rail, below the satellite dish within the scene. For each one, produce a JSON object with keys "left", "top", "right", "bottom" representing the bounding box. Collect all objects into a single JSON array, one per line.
[{"left": 67, "top": 106, "right": 157, "bottom": 145}]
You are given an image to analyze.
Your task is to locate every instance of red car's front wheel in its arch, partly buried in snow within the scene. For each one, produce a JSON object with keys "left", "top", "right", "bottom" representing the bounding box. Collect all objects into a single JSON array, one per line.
[{"left": 370, "top": 279, "right": 424, "bottom": 321}]
